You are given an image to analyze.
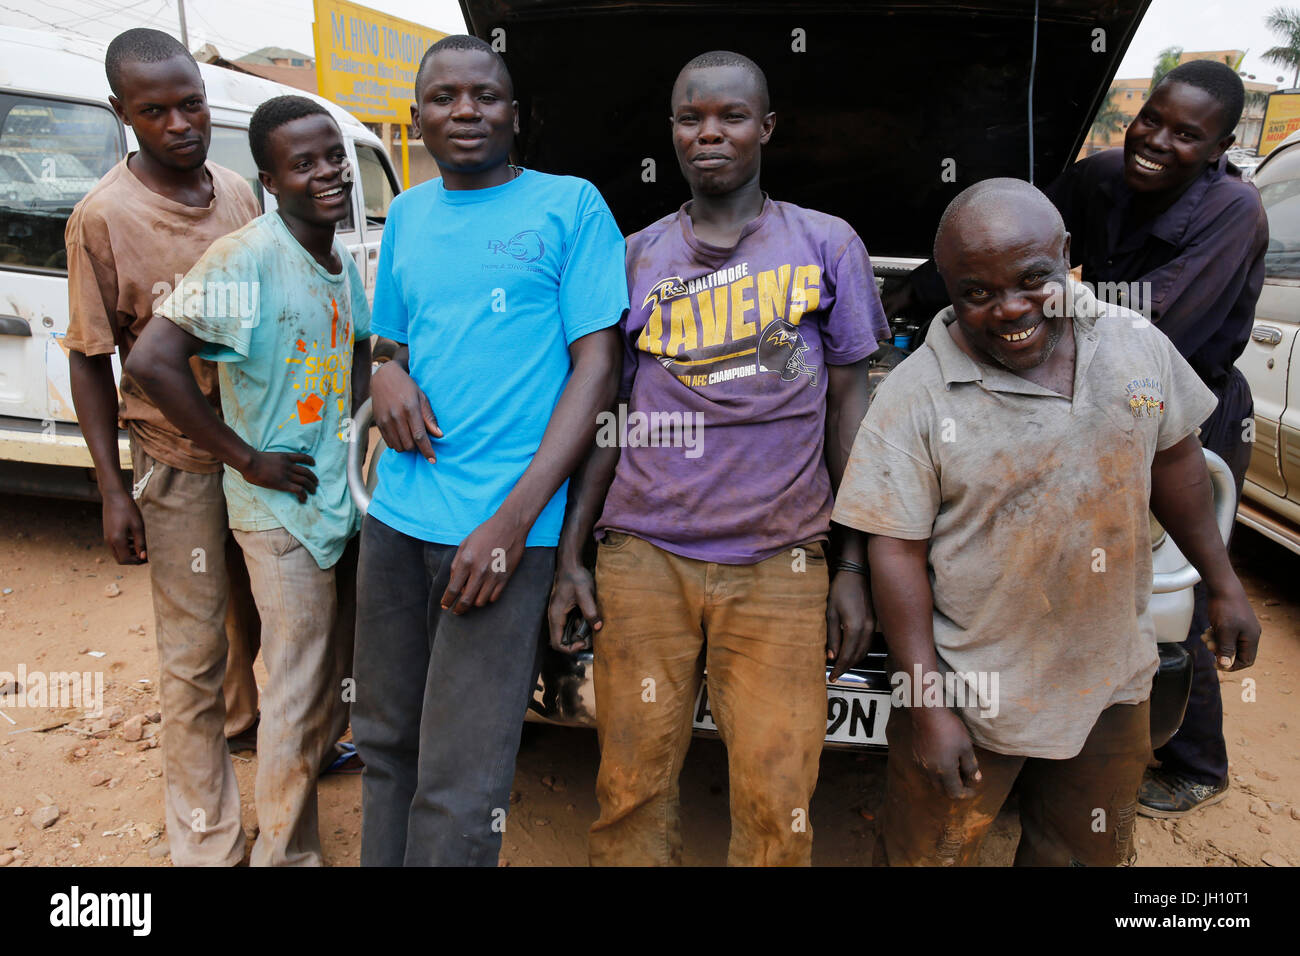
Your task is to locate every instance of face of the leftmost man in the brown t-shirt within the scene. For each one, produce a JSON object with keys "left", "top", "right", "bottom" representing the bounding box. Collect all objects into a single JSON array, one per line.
[{"left": 108, "top": 56, "right": 212, "bottom": 170}]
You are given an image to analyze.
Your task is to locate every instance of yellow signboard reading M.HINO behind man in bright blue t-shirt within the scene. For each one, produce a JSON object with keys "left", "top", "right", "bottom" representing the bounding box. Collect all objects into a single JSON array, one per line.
[{"left": 315, "top": 0, "right": 447, "bottom": 124}]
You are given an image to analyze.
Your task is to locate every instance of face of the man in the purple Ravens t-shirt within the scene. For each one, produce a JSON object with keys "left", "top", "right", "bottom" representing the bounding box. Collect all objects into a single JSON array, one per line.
[{"left": 672, "top": 66, "right": 776, "bottom": 195}]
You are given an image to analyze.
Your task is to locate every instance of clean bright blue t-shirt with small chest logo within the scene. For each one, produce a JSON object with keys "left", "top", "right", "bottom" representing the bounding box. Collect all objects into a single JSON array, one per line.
[{"left": 371, "top": 169, "right": 628, "bottom": 546}]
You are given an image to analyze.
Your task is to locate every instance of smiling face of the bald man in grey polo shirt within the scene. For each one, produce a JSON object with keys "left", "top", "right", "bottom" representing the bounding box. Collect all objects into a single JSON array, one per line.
[{"left": 936, "top": 195, "right": 1070, "bottom": 372}]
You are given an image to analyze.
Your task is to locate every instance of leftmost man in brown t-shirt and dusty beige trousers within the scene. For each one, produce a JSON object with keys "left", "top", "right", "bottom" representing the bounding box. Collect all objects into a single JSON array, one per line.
[{"left": 65, "top": 29, "right": 259, "bottom": 866}]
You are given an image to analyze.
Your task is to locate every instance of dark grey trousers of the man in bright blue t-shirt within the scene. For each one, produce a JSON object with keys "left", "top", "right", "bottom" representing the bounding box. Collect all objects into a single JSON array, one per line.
[{"left": 352, "top": 515, "right": 555, "bottom": 866}]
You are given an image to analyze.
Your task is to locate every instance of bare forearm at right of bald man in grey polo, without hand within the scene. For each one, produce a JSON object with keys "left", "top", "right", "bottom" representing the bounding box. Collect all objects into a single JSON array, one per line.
[{"left": 1151, "top": 434, "right": 1236, "bottom": 589}]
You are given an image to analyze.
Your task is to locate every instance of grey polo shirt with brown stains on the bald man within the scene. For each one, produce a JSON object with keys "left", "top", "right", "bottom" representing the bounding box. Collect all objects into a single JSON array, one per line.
[{"left": 832, "top": 282, "right": 1216, "bottom": 758}]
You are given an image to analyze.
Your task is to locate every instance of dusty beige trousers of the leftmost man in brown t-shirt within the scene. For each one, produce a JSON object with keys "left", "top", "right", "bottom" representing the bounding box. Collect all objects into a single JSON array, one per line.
[{"left": 131, "top": 434, "right": 244, "bottom": 866}]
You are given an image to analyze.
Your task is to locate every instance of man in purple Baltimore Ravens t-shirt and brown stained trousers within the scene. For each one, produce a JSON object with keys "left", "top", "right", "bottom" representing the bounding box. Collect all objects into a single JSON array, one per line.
[{"left": 550, "top": 52, "right": 888, "bottom": 865}]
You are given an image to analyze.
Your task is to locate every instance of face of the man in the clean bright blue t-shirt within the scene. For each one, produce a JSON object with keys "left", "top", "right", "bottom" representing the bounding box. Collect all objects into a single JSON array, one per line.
[{"left": 411, "top": 49, "right": 519, "bottom": 178}]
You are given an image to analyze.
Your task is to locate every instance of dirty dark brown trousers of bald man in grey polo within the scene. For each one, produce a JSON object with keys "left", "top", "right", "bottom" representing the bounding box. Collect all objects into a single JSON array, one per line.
[{"left": 875, "top": 701, "right": 1151, "bottom": 866}]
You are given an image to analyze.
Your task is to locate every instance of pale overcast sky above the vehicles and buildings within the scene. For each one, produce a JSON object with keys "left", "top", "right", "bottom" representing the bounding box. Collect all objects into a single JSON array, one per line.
[{"left": 0, "top": 0, "right": 1300, "bottom": 83}]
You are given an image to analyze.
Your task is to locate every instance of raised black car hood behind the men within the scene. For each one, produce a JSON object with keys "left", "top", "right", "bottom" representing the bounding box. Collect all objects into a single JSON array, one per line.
[{"left": 460, "top": 0, "right": 1151, "bottom": 256}]
